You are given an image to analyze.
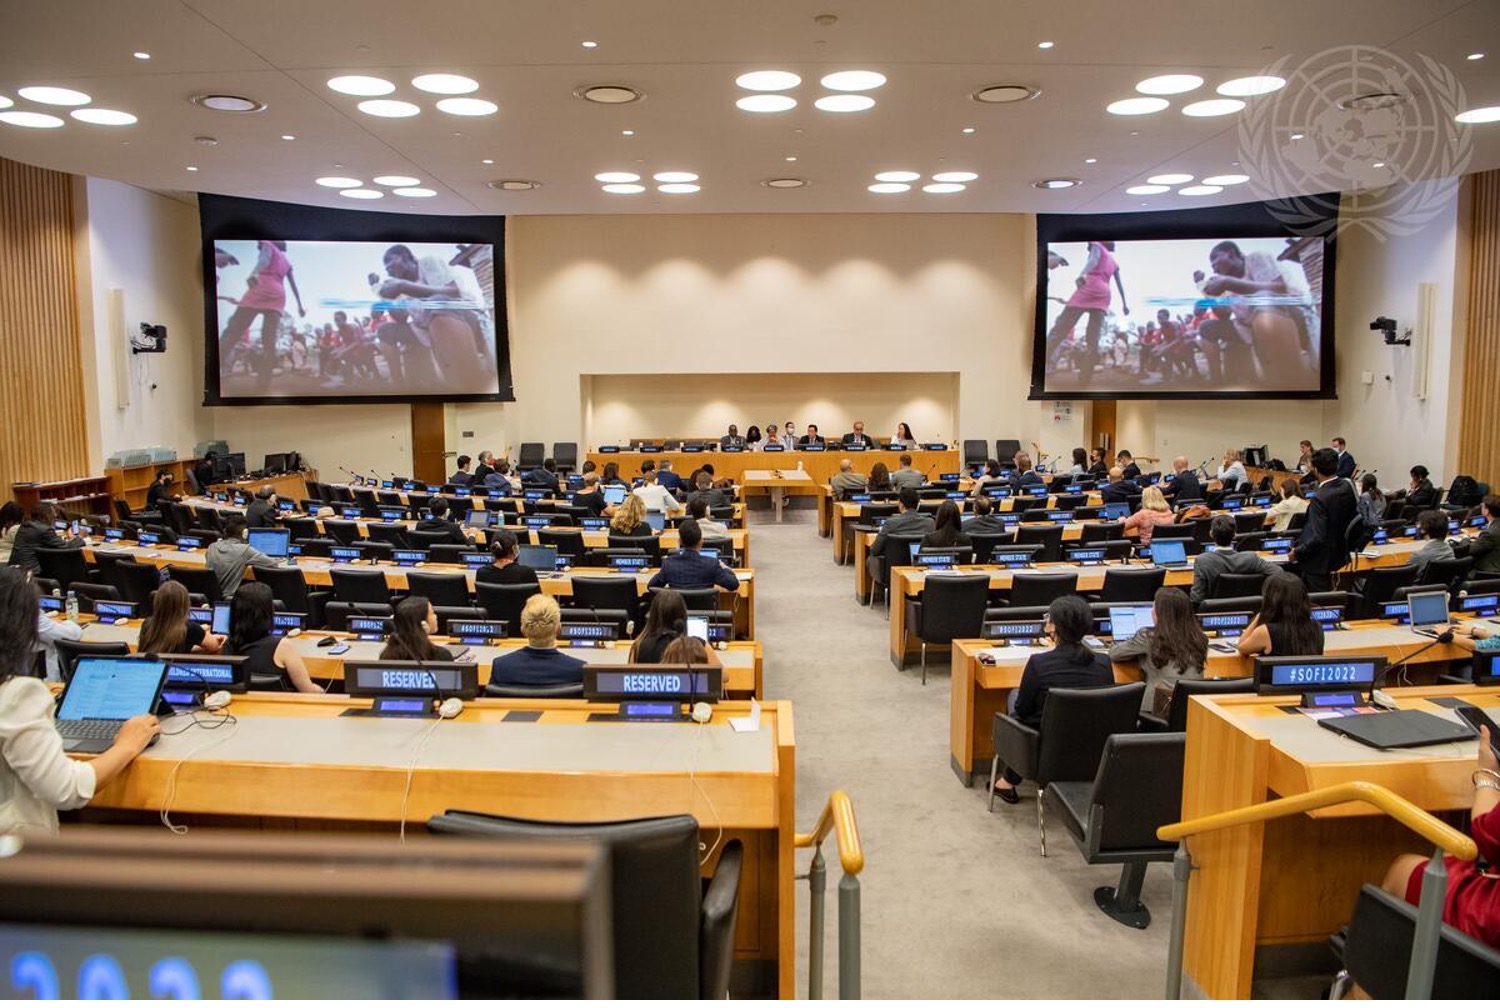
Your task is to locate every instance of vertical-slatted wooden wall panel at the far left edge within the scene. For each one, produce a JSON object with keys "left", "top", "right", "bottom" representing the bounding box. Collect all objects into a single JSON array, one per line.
[{"left": 0, "top": 159, "right": 89, "bottom": 500}]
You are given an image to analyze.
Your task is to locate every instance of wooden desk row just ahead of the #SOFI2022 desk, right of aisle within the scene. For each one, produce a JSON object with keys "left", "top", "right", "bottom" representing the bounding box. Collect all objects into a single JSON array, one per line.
[{"left": 948, "top": 620, "right": 1467, "bottom": 788}]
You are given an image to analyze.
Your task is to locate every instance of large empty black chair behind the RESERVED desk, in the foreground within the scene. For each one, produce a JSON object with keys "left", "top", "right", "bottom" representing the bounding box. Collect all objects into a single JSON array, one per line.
[{"left": 428, "top": 810, "right": 744, "bottom": 1001}]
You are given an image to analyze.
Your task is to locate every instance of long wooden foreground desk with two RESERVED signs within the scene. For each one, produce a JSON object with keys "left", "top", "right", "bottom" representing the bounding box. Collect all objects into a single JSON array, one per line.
[{"left": 72, "top": 695, "right": 797, "bottom": 998}]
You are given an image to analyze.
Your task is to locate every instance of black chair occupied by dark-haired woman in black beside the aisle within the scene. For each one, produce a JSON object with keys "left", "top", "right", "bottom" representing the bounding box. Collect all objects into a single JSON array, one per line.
[{"left": 990, "top": 683, "right": 1146, "bottom": 840}]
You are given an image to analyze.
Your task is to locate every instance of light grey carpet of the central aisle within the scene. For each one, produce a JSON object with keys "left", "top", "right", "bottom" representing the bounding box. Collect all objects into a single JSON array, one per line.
[{"left": 750, "top": 510, "right": 1172, "bottom": 998}]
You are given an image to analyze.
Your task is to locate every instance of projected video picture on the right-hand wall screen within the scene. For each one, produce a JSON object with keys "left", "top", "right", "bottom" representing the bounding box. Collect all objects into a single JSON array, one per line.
[{"left": 1037, "top": 237, "right": 1323, "bottom": 396}]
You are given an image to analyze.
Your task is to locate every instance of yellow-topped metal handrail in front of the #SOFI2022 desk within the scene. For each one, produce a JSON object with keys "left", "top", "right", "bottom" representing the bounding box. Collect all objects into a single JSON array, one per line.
[{"left": 1157, "top": 780, "right": 1479, "bottom": 1001}]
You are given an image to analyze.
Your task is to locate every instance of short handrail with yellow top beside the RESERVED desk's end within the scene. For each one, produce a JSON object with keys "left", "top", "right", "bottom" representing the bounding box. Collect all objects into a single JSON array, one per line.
[{"left": 794, "top": 791, "right": 864, "bottom": 1001}]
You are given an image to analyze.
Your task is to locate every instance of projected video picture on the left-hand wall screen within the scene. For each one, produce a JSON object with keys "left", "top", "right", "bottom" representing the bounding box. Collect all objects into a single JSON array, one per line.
[{"left": 213, "top": 240, "right": 501, "bottom": 399}]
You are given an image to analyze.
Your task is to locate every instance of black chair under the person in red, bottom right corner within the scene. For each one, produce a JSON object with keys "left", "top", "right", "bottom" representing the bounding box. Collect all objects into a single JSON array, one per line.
[{"left": 1329, "top": 885, "right": 1500, "bottom": 1001}]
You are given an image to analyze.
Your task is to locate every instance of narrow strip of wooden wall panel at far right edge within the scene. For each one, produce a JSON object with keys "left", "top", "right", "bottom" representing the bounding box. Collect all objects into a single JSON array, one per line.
[{"left": 1458, "top": 171, "right": 1500, "bottom": 486}]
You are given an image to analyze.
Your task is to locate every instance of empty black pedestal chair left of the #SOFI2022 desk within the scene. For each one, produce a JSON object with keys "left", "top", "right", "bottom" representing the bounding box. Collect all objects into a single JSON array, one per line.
[{"left": 1046, "top": 732, "right": 1188, "bottom": 929}]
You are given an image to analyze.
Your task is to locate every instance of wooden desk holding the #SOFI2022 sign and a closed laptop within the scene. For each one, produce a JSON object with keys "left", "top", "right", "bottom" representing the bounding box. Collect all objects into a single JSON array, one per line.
[{"left": 1182, "top": 686, "right": 1500, "bottom": 999}]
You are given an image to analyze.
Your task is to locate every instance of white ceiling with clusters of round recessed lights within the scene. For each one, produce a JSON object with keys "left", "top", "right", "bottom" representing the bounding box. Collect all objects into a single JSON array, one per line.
[{"left": 0, "top": 0, "right": 1500, "bottom": 215}]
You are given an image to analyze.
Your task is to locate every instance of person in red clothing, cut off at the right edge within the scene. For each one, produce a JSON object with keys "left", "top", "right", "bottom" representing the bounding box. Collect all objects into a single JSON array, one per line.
[{"left": 1380, "top": 728, "right": 1500, "bottom": 948}]
